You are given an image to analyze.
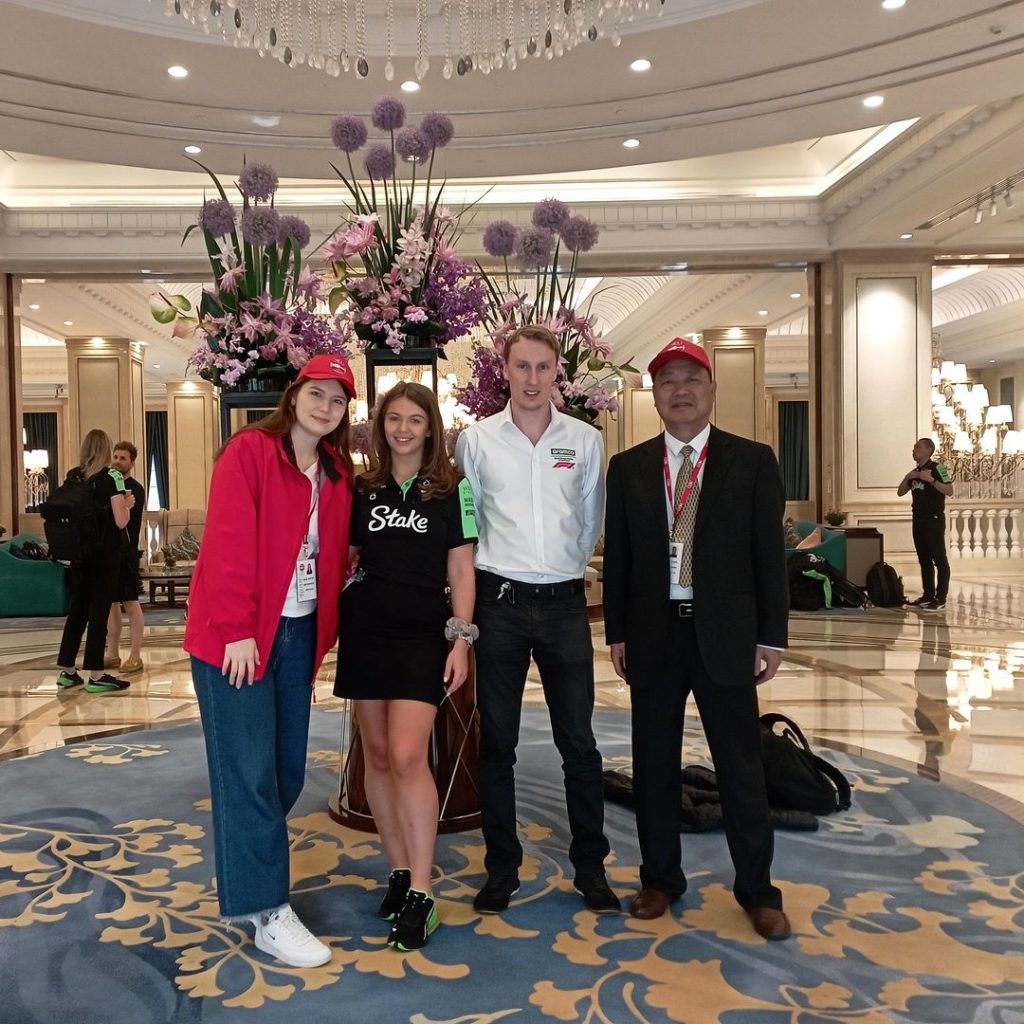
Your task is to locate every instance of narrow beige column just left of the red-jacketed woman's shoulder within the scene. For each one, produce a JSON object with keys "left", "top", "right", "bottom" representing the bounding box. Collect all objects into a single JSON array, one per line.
[{"left": 165, "top": 380, "right": 220, "bottom": 509}]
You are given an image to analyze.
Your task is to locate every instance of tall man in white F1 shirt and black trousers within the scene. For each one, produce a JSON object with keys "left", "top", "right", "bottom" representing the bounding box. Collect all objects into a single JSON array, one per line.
[{"left": 456, "top": 327, "right": 620, "bottom": 913}]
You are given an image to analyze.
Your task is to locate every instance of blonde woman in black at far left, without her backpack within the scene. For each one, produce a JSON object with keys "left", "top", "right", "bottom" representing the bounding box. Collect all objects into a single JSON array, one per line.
[{"left": 57, "top": 430, "right": 135, "bottom": 693}]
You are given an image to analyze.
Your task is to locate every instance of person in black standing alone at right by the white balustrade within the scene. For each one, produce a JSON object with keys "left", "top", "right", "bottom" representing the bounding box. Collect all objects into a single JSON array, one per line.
[{"left": 896, "top": 437, "right": 953, "bottom": 611}]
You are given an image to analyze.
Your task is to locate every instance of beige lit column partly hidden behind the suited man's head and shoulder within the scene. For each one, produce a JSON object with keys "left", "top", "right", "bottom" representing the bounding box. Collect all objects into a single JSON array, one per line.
[{"left": 700, "top": 327, "right": 768, "bottom": 441}]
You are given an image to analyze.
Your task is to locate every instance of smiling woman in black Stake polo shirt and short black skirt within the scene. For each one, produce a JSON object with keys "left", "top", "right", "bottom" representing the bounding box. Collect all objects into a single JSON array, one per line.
[{"left": 334, "top": 383, "right": 477, "bottom": 950}]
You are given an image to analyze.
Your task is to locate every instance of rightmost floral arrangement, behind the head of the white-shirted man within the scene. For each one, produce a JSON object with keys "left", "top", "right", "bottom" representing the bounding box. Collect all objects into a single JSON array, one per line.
[{"left": 458, "top": 199, "right": 638, "bottom": 423}]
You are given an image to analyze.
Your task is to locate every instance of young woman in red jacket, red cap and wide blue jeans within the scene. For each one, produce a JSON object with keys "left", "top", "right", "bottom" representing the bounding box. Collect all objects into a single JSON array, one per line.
[{"left": 184, "top": 355, "right": 355, "bottom": 967}]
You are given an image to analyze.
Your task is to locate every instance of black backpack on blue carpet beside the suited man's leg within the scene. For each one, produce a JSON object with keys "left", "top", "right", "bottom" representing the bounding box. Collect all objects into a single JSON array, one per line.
[{"left": 761, "top": 713, "right": 850, "bottom": 814}]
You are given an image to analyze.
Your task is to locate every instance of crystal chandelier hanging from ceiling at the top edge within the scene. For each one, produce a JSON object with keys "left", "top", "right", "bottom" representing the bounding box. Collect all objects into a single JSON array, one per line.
[{"left": 159, "top": 0, "right": 665, "bottom": 82}]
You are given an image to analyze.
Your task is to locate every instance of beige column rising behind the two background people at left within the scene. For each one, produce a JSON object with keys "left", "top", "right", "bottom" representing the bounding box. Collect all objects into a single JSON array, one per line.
[{"left": 65, "top": 337, "right": 146, "bottom": 482}]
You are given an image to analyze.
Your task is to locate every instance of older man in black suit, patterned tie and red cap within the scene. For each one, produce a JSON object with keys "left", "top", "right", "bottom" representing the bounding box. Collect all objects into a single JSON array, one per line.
[{"left": 604, "top": 338, "right": 790, "bottom": 939}]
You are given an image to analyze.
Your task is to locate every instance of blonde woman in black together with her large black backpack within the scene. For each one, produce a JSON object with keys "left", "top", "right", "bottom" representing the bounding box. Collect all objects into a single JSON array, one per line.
[{"left": 41, "top": 430, "right": 135, "bottom": 693}]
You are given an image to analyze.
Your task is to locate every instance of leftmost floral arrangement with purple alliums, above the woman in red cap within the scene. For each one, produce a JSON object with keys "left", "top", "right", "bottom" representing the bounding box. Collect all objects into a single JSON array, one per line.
[{"left": 150, "top": 161, "right": 350, "bottom": 390}]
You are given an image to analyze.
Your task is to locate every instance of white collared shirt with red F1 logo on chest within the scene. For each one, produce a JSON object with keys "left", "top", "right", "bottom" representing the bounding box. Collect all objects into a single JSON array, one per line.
[{"left": 455, "top": 403, "right": 604, "bottom": 583}]
